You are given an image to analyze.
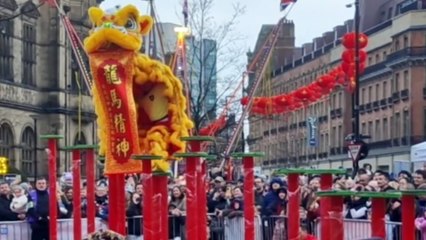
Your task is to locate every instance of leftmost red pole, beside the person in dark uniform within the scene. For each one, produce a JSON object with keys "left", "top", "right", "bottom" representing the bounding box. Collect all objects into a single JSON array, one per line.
[{"left": 47, "top": 138, "right": 58, "bottom": 240}]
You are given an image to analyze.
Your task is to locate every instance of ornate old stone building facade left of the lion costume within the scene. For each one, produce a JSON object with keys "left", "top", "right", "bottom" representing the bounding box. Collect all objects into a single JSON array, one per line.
[{"left": 0, "top": 0, "right": 100, "bottom": 180}]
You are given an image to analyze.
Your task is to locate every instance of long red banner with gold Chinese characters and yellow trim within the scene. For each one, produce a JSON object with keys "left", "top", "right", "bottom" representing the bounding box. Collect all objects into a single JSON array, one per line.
[{"left": 90, "top": 51, "right": 142, "bottom": 174}]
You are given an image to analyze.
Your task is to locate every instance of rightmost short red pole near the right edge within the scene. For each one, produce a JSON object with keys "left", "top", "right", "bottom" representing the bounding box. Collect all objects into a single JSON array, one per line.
[{"left": 401, "top": 194, "right": 416, "bottom": 240}]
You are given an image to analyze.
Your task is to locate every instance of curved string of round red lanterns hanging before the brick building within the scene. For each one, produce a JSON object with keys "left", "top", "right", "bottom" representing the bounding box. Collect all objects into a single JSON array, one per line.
[{"left": 241, "top": 32, "right": 368, "bottom": 115}]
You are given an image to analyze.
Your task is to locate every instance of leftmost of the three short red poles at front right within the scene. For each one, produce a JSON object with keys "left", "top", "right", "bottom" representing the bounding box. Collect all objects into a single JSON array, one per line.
[{"left": 326, "top": 197, "right": 345, "bottom": 240}]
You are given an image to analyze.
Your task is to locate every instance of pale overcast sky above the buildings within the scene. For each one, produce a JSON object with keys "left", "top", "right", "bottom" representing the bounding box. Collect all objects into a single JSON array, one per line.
[{"left": 101, "top": 0, "right": 354, "bottom": 49}]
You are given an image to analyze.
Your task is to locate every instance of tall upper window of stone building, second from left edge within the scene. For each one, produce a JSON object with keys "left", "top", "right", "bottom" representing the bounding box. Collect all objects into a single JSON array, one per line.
[{"left": 22, "top": 23, "right": 36, "bottom": 86}]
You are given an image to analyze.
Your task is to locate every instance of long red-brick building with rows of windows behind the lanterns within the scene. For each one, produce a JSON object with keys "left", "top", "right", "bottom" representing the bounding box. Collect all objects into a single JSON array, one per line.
[{"left": 248, "top": 0, "right": 426, "bottom": 172}]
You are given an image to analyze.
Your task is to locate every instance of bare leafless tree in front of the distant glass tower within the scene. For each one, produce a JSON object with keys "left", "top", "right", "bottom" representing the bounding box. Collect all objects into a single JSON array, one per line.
[{"left": 187, "top": 0, "right": 246, "bottom": 132}]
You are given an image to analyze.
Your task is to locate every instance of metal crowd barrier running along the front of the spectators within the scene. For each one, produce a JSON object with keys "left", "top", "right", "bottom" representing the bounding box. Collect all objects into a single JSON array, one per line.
[{"left": 0, "top": 215, "right": 412, "bottom": 240}]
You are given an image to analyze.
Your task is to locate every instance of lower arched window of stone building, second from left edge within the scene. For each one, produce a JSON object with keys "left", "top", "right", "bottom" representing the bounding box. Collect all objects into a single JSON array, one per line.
[{"left": 21, "top": 127, "right": 36, "bottom": 176}]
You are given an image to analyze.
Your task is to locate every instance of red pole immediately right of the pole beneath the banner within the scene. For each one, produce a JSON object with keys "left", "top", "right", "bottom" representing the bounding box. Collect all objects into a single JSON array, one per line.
[{"left": 142, "top": 160, "right": 154, "bottom": 240}]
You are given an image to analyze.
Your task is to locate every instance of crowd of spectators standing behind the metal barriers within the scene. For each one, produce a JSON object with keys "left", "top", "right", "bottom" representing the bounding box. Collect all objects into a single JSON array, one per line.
[{"left": 0, "top": 165, "right": 426, "bottom": 240}]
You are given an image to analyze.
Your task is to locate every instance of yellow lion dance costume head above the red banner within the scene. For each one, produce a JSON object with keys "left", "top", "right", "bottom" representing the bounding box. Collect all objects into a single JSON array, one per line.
[{"left": 84, "top": 5, "right": 153, "bottom": 54}]
